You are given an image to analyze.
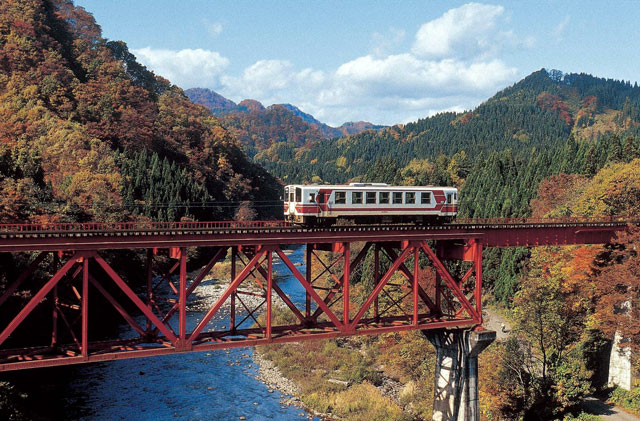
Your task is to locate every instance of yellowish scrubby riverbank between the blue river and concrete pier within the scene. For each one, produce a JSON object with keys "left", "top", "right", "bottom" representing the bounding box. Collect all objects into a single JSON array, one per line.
[{"left": 258, "top": 324, "right": 435, "bottom": 420}]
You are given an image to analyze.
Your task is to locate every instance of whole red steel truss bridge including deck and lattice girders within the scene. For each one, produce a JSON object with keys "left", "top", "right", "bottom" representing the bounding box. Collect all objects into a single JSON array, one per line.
[{"left": 0, "top": 219, "right": 628, "bottom": 371}]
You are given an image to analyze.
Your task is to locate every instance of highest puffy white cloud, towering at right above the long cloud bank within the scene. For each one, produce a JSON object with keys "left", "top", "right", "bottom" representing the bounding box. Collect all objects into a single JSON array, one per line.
[{"left": 412, "top": 3, "right": 504, "bottom": 59}]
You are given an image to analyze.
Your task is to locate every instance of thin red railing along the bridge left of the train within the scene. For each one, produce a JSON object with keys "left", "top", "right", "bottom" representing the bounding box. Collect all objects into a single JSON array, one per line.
[{"left": 0, "top": 221, "right": 289, "bottom": 234}]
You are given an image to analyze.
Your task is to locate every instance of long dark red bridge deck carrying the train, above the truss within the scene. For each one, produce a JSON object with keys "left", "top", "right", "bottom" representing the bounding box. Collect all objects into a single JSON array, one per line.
[{"left": 0, "top": 219, "right": 630, "bottom": 252}]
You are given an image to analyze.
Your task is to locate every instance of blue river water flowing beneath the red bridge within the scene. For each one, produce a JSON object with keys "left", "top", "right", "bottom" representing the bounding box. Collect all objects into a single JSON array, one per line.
[{"left": 63, "top": 247, "right": 318, "bottom": 421}]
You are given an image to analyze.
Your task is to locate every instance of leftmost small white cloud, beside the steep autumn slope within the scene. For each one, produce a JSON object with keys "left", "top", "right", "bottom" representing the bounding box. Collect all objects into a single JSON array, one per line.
[{"left": 131, "top": 47, "right": 229, "bottom": 89}]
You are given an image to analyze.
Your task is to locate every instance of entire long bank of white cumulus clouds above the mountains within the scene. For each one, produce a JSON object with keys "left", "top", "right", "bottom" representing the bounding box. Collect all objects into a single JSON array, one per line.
[{"left": 133, "top": 3, "right": 528, "bottom": 125}]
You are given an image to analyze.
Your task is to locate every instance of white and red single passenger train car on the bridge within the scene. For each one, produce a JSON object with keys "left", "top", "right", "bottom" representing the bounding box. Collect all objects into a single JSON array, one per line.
[{"left": 284, "top": 183, "right": 458, "bottom": 226}]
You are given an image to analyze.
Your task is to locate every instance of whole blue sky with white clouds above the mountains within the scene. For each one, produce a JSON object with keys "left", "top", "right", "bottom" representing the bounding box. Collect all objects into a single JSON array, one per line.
[{"left": 75, "top": 0, "right": 640, "bottom": 126}]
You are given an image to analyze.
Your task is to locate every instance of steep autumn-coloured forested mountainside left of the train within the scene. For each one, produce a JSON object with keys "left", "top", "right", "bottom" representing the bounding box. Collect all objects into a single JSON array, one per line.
[{"left": 0, "top": 0, "right": 280, "bottom": 222}]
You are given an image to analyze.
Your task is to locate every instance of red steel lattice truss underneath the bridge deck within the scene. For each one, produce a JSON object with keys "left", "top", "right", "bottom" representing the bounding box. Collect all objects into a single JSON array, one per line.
[{"left": 0, "top": 238, "right": 482, "bottom": 371}]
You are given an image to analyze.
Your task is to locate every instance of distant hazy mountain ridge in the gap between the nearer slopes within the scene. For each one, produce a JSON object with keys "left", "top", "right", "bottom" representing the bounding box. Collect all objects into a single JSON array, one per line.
[{"left": 185, "top": 88, "right": 384, "bottom": 157}]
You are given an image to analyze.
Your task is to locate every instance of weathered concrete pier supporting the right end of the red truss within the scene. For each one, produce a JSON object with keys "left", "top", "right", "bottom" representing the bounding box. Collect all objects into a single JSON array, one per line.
[{"left": 423, "top": 329, "right": 496, "bottom": 421}]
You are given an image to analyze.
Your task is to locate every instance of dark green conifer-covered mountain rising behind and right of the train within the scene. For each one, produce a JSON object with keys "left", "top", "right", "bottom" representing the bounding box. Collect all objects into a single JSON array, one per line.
[{"left": 256, "top": 69, "right": 640, "bottom": 182}]
